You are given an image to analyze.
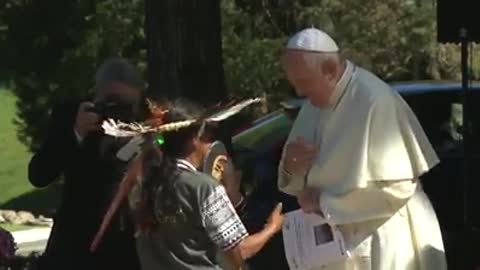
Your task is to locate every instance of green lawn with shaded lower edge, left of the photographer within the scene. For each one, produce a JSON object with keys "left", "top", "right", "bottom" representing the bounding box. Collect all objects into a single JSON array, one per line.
[{"left": 0, "top": 89, "right": 58, "bottom": 214}]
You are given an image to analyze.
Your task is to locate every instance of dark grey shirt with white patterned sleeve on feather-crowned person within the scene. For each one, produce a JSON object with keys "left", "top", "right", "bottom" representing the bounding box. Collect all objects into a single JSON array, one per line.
[{"left": 137, "top": 160, "right": 248, "bottom": 270}]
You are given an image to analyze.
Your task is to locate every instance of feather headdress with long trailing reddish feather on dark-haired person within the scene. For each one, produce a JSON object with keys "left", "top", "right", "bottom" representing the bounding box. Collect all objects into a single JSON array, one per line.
[{"left": 90, "top": 98, "right": 263, "bottom": 252}]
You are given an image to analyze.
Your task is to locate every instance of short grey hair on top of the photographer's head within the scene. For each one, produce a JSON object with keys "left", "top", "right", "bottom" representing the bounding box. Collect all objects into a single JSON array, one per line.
[{"left": 95, "top": 57, "right": 144, "bottom": 90}]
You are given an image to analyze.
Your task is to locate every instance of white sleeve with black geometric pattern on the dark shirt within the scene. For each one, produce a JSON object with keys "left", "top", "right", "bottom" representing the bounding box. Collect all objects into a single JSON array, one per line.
[{"left": 200, "top": 185, "right": 248, "bottom": 250}]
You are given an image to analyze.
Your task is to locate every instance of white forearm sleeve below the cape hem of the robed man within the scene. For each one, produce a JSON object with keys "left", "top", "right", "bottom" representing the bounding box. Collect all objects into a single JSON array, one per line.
[{"left": 320, "top": 180, "right": 417, "bottom": 224}]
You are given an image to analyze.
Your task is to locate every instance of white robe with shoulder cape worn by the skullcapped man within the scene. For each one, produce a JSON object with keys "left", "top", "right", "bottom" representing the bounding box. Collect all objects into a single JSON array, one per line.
[{"left": 278, "top": 62, "right": 447, "bottom": 270}]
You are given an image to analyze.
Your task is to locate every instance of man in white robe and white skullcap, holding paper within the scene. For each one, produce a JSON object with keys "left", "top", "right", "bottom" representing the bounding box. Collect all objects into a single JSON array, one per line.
[{"left": 278, "top": 28, "right": 447, "bottom": 270}]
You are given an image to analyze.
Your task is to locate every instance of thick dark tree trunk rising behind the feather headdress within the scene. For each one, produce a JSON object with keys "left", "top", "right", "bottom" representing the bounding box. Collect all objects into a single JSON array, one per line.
[{"left": 145, "top": 0, "right": 227, "bottom": 105}]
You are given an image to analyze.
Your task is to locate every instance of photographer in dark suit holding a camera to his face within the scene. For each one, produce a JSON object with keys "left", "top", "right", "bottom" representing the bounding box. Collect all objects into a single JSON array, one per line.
[{"left": 28, "top": 58, "right": 144, "bottom": 270}]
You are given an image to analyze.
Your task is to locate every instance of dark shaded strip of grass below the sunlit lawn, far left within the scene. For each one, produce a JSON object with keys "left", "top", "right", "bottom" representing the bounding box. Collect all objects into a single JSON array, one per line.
[{"left": 0, "top": 183, "right": 62, "bottom": 217}]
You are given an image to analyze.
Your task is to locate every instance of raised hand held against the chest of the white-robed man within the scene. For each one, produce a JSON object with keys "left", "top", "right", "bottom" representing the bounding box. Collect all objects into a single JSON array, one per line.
[{"left": 283, "top": 137, "right": 317, "bottom": 175}]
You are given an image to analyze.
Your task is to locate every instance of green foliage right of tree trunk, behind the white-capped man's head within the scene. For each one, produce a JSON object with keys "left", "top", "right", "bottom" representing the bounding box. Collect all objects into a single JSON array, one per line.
[{"left": 222, "top": 0, "right": 480, "bottom": 104}]
